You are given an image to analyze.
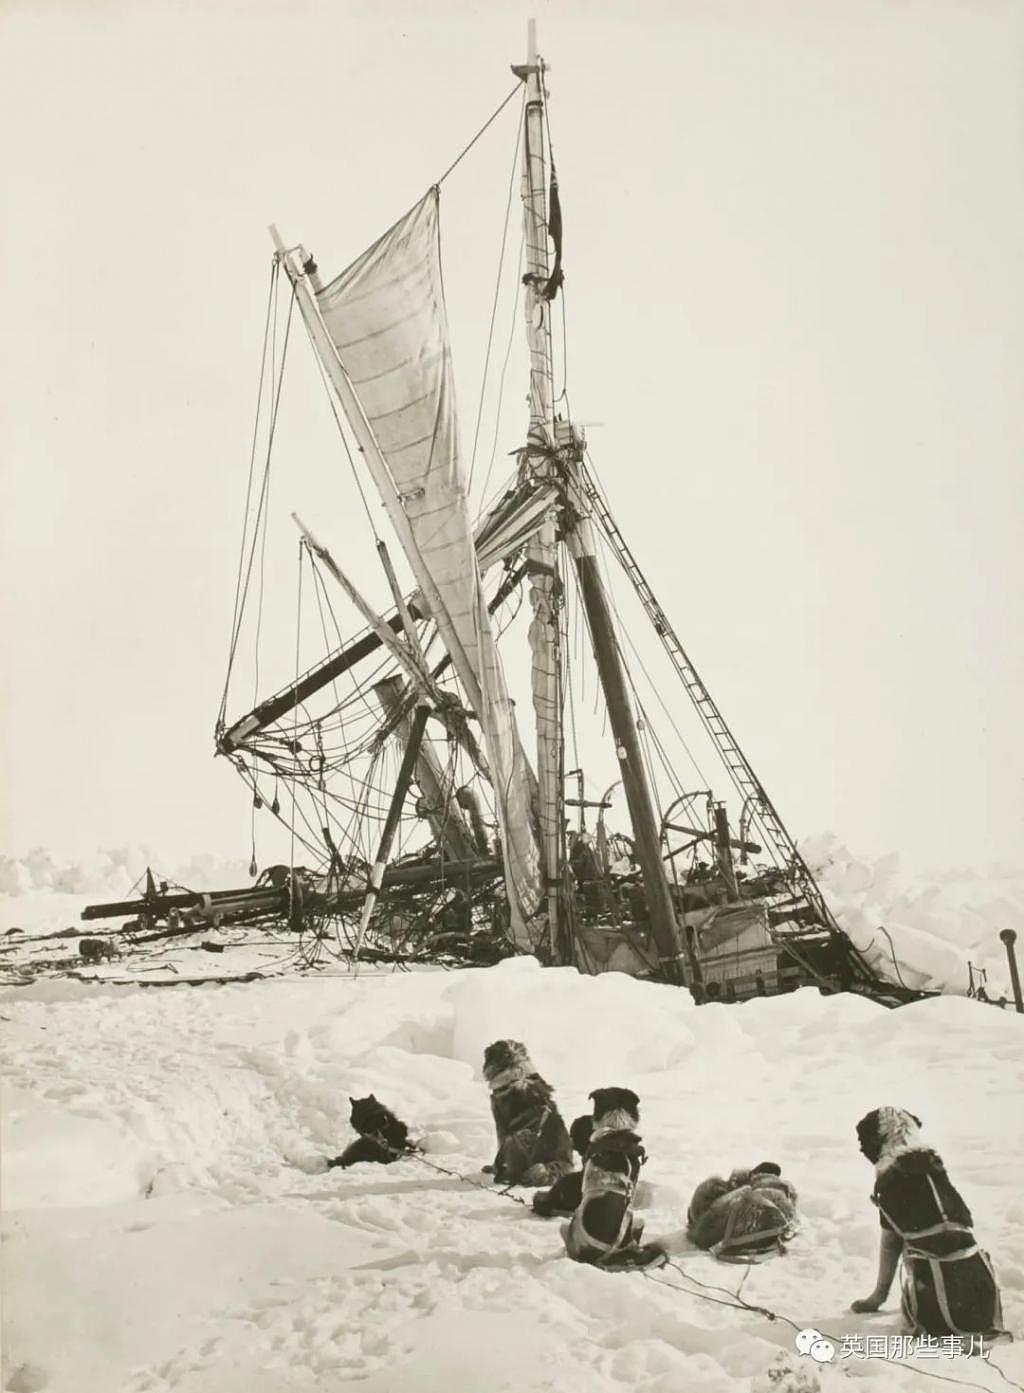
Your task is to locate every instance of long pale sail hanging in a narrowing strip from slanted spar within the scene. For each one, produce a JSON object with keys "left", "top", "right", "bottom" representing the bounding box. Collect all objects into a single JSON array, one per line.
[{"left": 316, "top": 188, "right": 543, "bottom": 947}]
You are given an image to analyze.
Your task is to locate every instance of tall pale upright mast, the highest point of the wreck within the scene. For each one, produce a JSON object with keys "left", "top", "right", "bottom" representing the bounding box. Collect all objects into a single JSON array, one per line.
[{"left": 513, "top": 20, "right": 566, "bottom": 961}]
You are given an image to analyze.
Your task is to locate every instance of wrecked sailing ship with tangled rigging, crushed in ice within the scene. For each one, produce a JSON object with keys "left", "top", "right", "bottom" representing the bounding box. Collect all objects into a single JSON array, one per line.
[{"left": 85, "top": 24, "right": 914, "bottom": 1004}]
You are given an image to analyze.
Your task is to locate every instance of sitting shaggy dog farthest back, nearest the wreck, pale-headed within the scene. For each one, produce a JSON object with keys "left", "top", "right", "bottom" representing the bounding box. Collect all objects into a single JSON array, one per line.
[{"left": 483, "top": 1041, "right": 573, "bottom": 1185}]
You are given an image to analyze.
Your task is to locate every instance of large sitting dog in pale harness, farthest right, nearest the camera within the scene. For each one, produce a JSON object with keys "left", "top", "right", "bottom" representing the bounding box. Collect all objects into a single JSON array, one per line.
[{"left": 853, "top": 1107, "right": 1003, "bottom": 1337}]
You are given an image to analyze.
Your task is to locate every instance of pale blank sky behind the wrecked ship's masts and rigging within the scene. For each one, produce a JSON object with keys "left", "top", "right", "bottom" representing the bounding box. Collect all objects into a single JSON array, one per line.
[{"left": 0, "top": 0, "right": 1024, "bottom": 869}]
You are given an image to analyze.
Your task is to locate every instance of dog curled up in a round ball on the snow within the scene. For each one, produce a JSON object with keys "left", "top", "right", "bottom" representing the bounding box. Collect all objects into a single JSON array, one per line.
[{"left": 687, "top": 1160, "right": 797, "bottom": 1262}]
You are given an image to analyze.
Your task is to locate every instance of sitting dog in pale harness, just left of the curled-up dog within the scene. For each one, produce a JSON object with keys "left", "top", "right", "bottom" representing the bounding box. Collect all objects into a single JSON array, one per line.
[{"left": 561, "top": 1088, "right": 666, "bottom": 1268}]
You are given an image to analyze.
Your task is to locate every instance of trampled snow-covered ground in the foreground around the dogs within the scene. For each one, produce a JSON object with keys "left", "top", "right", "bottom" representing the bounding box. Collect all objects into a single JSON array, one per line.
[{"left": 0, "top": 958, "right": 1024, "bottom": 1393}]
